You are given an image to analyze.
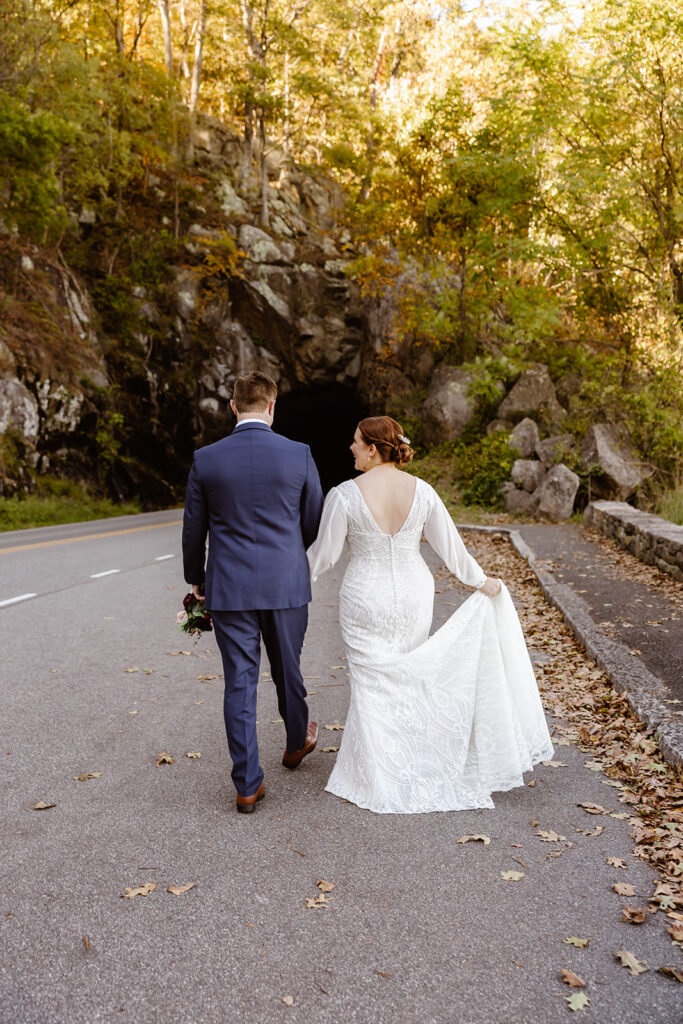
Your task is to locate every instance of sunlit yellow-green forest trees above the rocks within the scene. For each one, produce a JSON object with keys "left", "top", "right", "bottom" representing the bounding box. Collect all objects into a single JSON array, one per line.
[{"left": 0, "top": 0, "right": 683, "bottom": 497}]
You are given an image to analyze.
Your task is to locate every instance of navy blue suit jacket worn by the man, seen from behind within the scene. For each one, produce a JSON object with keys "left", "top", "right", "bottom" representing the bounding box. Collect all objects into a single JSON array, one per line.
[{"left": 182, "top": 423, "right": 323, "bottom": 611}]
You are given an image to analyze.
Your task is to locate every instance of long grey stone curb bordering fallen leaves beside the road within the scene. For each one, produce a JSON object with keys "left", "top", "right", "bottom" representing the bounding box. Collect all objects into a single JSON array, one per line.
[{"left": 458, "top": 523, "right": 683, "bottom": 766}]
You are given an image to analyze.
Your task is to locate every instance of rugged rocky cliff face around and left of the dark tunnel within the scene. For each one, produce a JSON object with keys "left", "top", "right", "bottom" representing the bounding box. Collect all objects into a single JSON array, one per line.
[{"left": 0, "top": 119, "right": 377, "bottom": 504}]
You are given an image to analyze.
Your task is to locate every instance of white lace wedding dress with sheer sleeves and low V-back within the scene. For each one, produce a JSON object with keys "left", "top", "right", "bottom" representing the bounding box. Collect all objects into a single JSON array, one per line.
[{"left": 308, "top": 479, "right": 553, "bottom": 814}]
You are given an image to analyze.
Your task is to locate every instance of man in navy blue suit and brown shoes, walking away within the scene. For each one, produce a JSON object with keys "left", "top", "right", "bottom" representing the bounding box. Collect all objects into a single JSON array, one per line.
[{"left": 182, "top": 371, "right": 323, "bottom": 814}]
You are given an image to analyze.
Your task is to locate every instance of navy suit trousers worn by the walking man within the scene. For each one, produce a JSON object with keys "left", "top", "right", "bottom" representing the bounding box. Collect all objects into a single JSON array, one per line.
[{"left": 211, "top": 604, "right": 308, "bottom": 797}]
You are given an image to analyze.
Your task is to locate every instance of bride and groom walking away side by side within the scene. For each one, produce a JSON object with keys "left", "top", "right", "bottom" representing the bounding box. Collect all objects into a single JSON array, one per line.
[{"left": 182, "top": 372, "right": 553, "bottom": 813}]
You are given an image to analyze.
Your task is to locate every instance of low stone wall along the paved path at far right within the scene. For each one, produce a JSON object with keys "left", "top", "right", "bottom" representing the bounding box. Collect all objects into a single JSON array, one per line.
[{"left": 584, "top": 502, "right": 683, "bottom": 583}]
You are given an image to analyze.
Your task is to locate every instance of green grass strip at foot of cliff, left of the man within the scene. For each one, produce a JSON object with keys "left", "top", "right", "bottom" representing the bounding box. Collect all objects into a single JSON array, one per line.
[{"left": 0, "top": 477, "right": 140, "bottom": 531}]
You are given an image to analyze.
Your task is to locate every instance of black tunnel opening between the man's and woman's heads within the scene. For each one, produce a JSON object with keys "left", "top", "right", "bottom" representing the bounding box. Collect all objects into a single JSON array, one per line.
[{"left": 273, "top": 384, "right": 369, "bottom": 494}]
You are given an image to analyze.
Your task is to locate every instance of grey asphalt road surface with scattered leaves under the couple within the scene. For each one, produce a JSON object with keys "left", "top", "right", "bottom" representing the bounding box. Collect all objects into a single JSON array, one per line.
[{"left": 0, "top": 512, "right": 683, "bottom": 1024}]
